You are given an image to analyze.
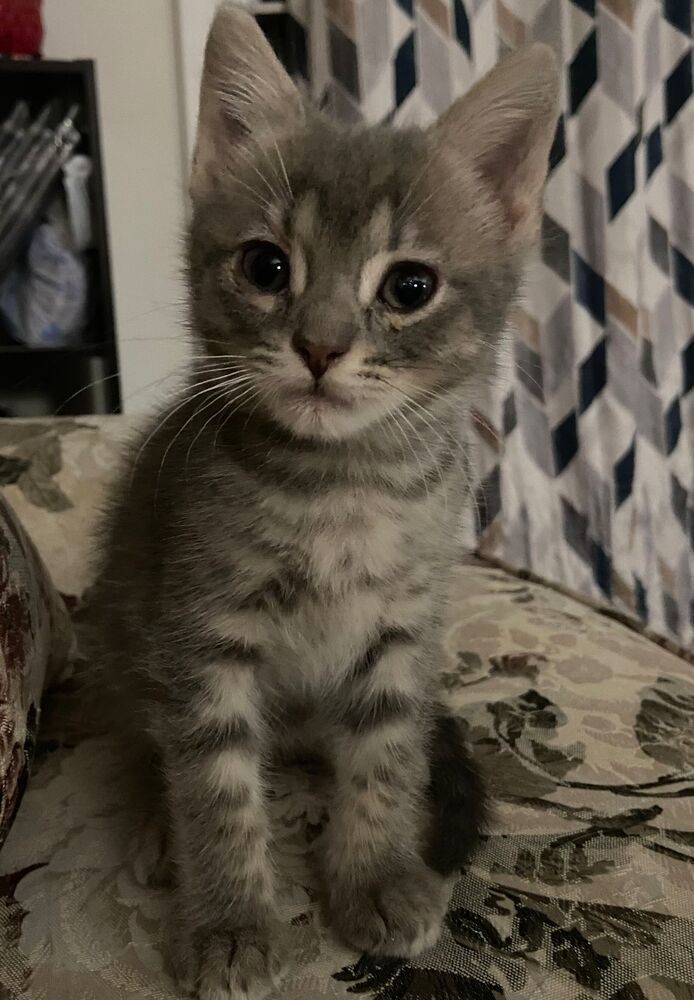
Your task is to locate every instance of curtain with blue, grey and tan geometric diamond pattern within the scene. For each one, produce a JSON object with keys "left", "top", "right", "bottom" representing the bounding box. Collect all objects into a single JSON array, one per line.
[{"left": 280, "top": 0, "right": 694, "bottom": 645}]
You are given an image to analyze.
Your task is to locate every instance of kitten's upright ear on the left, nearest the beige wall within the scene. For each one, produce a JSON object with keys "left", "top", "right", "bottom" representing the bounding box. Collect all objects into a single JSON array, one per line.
[{"left": 190, "top": 2, "right": 303, "bottom": 201}]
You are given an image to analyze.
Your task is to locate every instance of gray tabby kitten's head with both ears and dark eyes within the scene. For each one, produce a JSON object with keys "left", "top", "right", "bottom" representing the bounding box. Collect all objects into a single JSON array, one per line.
[{"left": 189, "top": 4, "right": 557, "bottom": 440}]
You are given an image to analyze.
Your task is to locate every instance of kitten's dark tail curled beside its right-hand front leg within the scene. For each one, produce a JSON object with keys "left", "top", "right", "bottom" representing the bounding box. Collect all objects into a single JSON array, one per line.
[{"left": 425, "top": 710, "right": 488, "bottom": 875}]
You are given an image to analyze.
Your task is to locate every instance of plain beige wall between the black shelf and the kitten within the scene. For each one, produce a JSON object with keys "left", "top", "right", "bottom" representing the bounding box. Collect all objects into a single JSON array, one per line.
[{"left": 44, "top": 0, "right": 187, "bottom": 412}]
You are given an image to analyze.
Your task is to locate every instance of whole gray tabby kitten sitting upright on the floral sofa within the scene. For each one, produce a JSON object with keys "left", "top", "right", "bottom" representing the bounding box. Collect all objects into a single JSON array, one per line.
[{"left": 91, "top": 5, "right": 557, "bottom": 1000}]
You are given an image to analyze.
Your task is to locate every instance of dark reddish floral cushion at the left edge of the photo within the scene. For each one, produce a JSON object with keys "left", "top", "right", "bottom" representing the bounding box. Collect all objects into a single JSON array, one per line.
[{"left": 0, "top": 495, "right": 71, "bottom": 847}]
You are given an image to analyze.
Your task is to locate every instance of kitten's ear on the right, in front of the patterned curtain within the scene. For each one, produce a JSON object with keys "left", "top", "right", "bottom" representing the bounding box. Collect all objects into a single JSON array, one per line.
[{"left": 433, "top": 44, "right": 559, "bottom": 251}]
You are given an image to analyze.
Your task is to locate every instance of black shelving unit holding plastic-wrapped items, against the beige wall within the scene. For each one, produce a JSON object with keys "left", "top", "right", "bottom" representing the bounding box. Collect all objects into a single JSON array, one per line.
[{"left": 0, "top": 57, "right": 121, "bottom": 416}]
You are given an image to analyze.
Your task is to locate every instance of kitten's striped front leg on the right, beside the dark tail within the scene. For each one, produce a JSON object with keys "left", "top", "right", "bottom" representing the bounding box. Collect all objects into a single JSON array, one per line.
[{"left": 326, "top": 630, "right": 448, "bottom": 957}]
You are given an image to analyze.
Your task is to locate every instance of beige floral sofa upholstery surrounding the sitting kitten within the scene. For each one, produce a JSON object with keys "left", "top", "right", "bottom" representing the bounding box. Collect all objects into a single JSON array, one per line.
[{"left": 0, "top": 420, "right": 694, "bottom": 1000}]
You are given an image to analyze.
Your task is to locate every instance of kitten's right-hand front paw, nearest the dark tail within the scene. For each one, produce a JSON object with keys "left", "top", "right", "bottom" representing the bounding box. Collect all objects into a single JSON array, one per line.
[{"left": 331, "top": 864, "right": 448, "bottom": 958}]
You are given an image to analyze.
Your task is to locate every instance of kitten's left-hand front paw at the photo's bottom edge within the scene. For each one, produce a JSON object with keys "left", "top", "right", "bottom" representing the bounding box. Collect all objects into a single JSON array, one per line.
[{"left": 182, "top": 928, "right": 286, "bottom": 1000}]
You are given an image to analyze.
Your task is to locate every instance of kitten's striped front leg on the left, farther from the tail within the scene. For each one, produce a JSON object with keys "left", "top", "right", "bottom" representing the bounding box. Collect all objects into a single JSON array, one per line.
[{"left": 163, "top": 651, "right": 282, "bottom": 1000}]
